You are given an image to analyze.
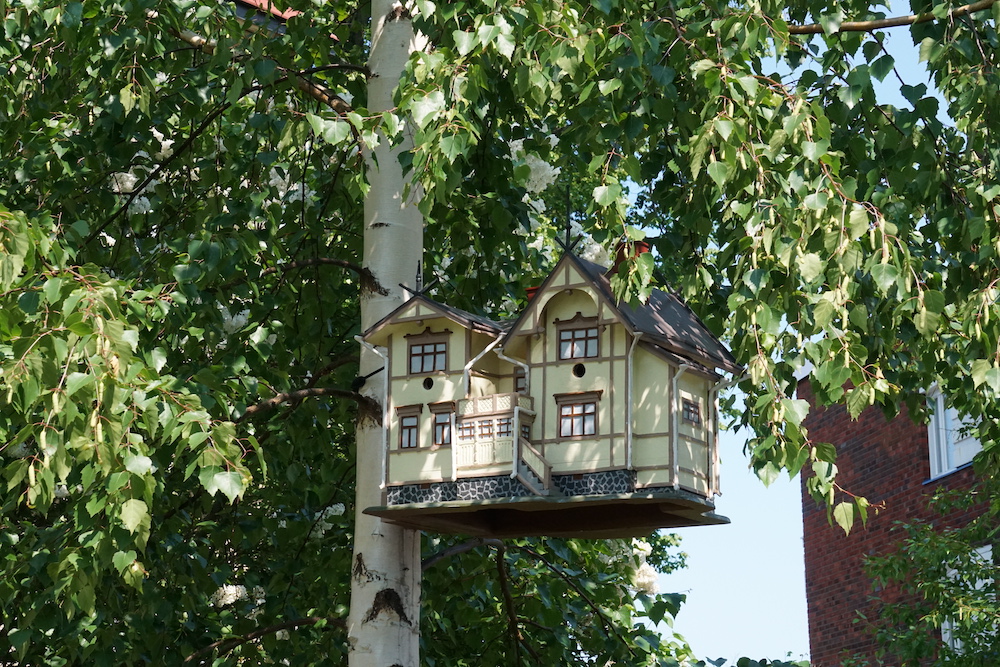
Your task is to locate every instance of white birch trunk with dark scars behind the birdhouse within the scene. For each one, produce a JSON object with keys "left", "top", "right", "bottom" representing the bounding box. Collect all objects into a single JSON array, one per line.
[{"left": 348, "top": 0, "right": 423, "bottom": 667}]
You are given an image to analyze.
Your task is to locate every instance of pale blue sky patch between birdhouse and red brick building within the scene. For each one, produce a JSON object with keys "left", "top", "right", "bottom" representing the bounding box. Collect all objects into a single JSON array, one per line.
[{"left": 659, "top": 432, "right": 808, "bottom": 660}]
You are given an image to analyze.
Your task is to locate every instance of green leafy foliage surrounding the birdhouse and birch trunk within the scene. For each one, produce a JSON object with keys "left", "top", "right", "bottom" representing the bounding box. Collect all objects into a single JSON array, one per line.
[{"left": 0, "top": 0, "right": 1000, "bottom": 664}]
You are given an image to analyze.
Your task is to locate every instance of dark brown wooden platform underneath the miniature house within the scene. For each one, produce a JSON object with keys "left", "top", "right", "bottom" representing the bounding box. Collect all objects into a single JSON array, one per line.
[{"left": 365, "top": 489, "right": 729, "bottom": 539}]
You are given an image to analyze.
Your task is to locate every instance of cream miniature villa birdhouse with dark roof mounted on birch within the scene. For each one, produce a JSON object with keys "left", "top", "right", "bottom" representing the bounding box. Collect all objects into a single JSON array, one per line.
[{"left": 364, "top": 253, "right": 739, "bottom": 538}]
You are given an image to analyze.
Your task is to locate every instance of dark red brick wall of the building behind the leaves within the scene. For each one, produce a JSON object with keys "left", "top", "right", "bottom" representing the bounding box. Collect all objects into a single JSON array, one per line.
[{"left": 798, "top": 382, "right": 972, "bottom": 667}]
